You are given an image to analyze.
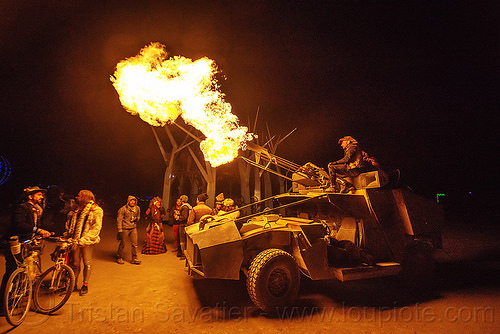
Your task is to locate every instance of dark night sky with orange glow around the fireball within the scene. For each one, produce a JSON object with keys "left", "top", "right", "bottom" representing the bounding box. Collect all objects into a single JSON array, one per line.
[{"left": 0, "top": 0, "right": 500, "bottom": 206}]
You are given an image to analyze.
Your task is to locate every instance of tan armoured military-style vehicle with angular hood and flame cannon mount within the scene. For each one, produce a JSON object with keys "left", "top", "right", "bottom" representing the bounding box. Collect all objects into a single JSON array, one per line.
[{"left": 181, "top": 145, "right": 442, "bottom": 312}]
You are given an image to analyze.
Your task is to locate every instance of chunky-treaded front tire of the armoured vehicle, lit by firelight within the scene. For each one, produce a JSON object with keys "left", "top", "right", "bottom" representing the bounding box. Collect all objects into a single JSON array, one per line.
[{"left": 247, "top": 248, "right": 300, "bottom": 313}]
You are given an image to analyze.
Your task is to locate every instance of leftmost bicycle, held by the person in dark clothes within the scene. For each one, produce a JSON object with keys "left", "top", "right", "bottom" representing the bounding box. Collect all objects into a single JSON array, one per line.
[{"left": 3, "top": 236, "right": 42, "bottom": 326}]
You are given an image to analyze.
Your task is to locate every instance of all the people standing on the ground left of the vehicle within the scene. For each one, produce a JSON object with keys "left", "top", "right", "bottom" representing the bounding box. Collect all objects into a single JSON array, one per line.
[{"left": 0, "top": 186, "right": 239, "bottom": 302}]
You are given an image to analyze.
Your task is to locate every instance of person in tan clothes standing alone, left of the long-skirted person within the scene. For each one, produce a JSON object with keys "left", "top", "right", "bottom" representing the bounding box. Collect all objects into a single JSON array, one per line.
[{"left": 116, "top": 195, "right": 141, "bottom": 264}]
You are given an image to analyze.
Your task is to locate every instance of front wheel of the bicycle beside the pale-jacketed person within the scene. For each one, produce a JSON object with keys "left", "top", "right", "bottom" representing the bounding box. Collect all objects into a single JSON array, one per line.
[{"left": 33, "top": 264, "right": 75, "bottom": 314}]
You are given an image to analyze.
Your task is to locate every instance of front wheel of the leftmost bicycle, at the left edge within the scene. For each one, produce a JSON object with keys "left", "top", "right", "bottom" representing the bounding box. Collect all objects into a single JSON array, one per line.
[{"left": 3, "top": 268, "right": 32, "bottom": 326}]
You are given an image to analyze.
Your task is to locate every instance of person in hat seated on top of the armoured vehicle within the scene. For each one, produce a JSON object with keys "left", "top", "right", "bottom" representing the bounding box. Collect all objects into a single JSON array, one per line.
[{"left": 328, "top": 136, "right": 364, "bottom": 192}]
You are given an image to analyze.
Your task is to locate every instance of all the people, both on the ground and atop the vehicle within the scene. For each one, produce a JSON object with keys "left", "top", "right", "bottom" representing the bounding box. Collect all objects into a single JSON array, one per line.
[{"left": 0, "top": 136, "right": 368, "bottom": 302}]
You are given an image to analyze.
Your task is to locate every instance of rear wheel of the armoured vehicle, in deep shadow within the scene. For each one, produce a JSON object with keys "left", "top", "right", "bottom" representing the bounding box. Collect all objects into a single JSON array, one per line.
[{"left": 399, "top": 242, "right": 435, "bottom": 291}]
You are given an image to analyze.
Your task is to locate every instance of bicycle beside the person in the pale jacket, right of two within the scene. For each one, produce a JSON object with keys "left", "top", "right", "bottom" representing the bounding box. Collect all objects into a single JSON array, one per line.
[{"left": 33, "top": 237, "right": 75, "bottom": 314}]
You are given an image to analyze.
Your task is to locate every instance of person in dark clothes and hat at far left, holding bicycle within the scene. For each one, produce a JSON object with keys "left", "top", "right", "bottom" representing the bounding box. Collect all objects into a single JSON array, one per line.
[{"left": 0, "top": 186, "right": 50, "bottom": 304}]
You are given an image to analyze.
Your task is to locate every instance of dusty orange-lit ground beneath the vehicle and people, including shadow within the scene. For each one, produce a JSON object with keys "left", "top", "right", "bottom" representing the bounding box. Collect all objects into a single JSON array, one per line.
[{"left": 0, "top": 217, "right": 500, "bottom": 334}]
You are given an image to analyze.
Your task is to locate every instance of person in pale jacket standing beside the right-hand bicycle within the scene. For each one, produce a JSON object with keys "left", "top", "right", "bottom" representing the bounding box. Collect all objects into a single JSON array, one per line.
[{"left": 65, "top": 190, "right": 104, "bottom": 296}]
